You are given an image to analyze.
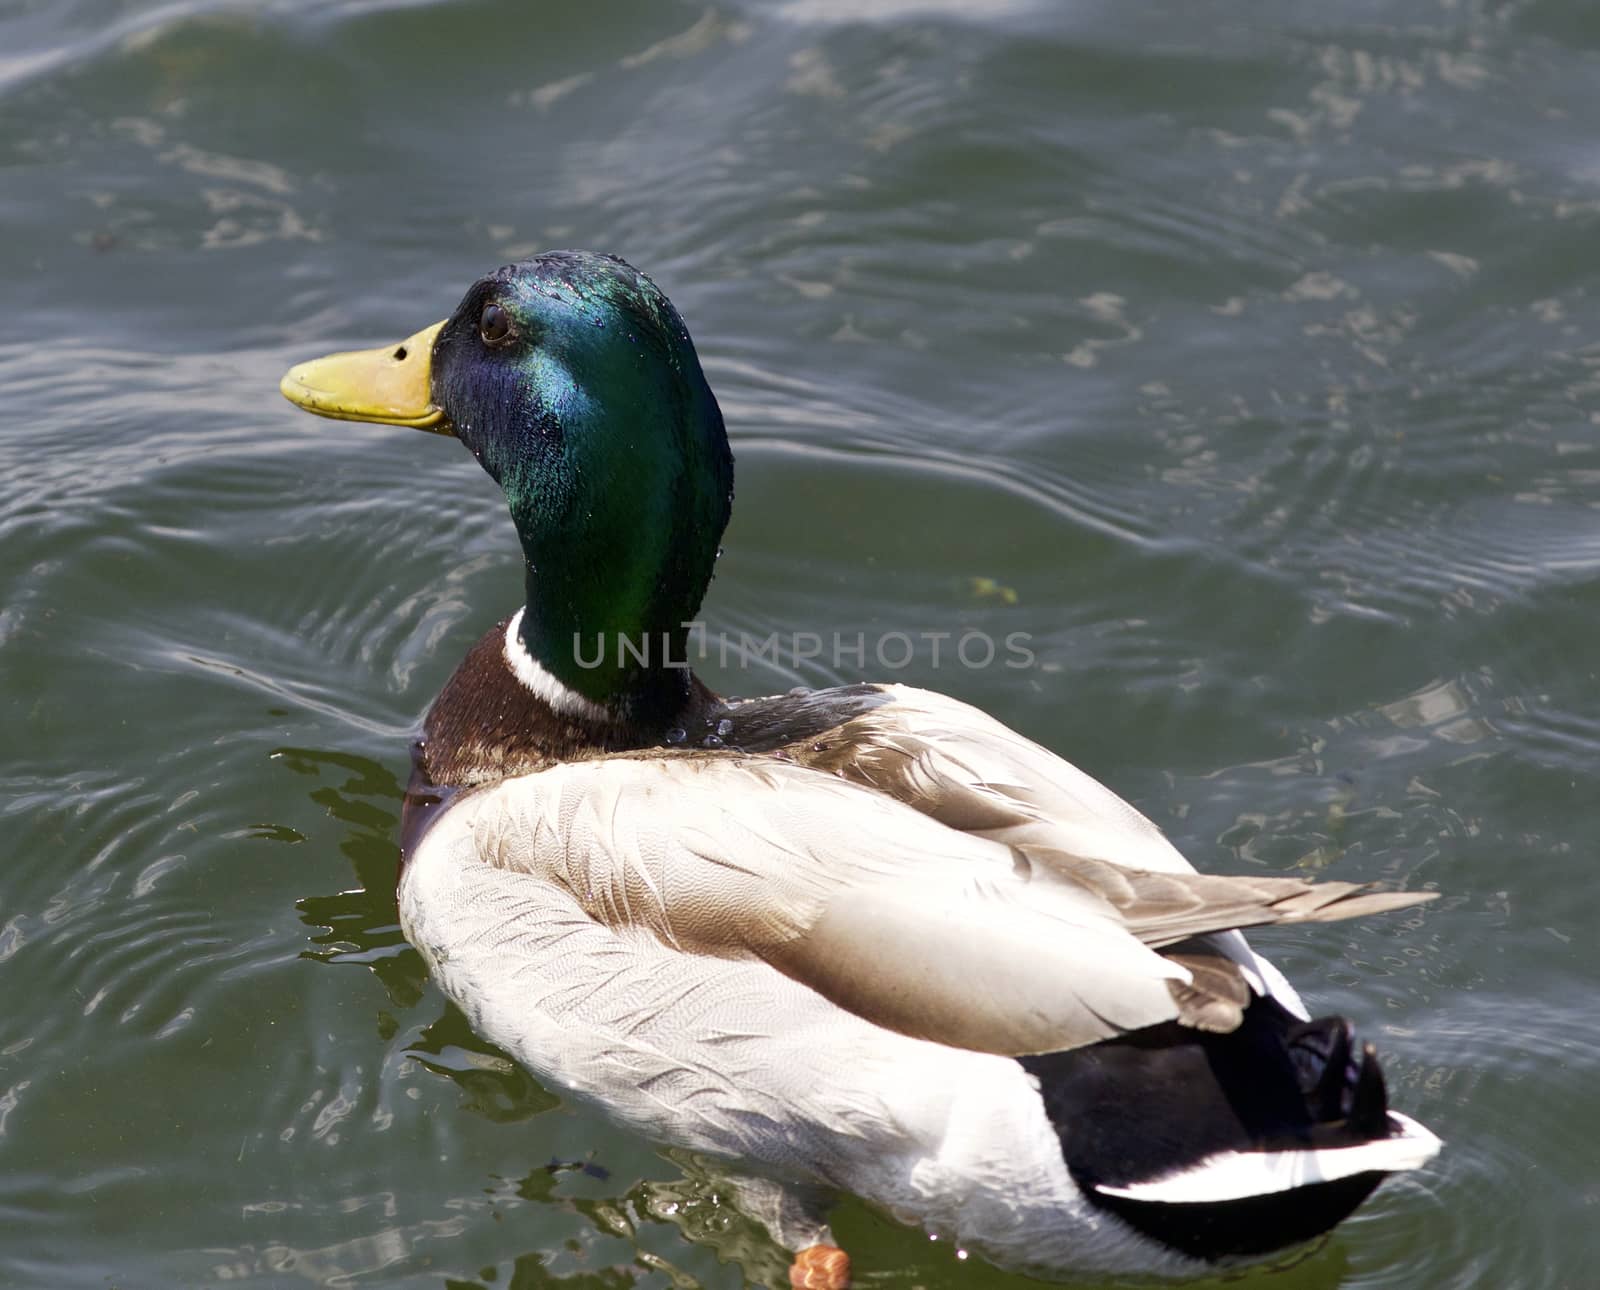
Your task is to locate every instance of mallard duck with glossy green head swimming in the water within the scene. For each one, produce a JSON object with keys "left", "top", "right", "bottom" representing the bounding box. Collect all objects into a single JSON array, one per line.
[{"left": 282, "top": 251, "right": 1440, "bottom": 1290}]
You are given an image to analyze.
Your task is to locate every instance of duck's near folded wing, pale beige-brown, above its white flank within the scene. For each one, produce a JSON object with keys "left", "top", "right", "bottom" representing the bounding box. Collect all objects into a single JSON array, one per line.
[{"left": 460, "top": 755, "right": 1427, "bottom": 1055}]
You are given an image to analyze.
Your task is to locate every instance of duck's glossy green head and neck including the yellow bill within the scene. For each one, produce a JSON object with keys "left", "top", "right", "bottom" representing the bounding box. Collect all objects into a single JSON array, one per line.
[{"left": 282, "top": 251, "right": 733, "bottom": 717}]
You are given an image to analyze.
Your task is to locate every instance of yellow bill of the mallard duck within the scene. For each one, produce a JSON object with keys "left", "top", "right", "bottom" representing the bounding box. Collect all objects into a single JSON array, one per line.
[{"left": 278, "top": 322, "right": 454, "bottom": 435}]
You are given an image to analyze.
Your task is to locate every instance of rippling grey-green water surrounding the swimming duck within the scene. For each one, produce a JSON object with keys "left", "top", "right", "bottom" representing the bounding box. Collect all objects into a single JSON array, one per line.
[{"left": 0, "top": 0, "right": 1600, "bottom": 1290}]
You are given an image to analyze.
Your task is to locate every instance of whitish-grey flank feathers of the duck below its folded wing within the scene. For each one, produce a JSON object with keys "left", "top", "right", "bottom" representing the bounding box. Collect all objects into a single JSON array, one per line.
[{"left": 400, "top": 806, "right": 1194, "bottom": 1274}]
